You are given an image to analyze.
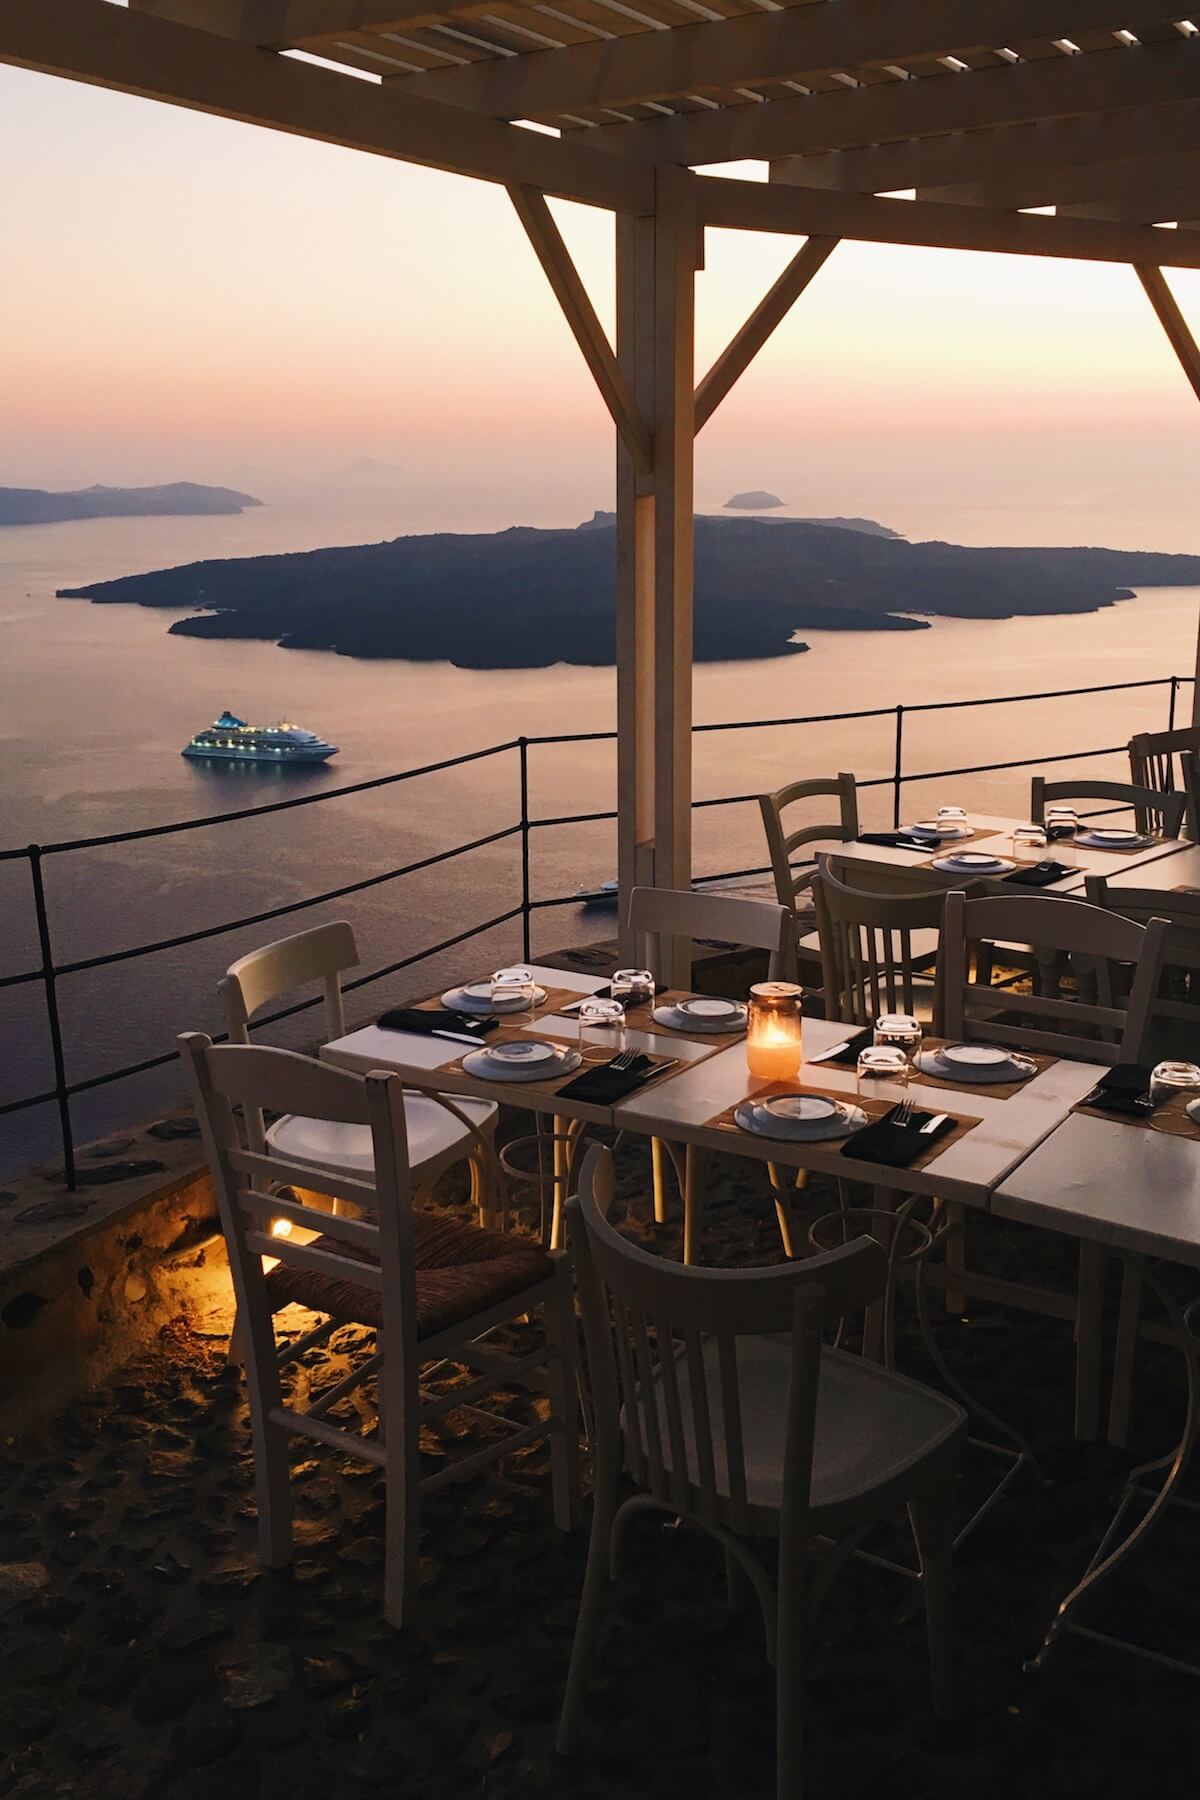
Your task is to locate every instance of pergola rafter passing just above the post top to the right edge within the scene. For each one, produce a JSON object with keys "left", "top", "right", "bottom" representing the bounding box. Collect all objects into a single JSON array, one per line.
[{"left": 588, "top": 38, "right": 1200, "bottom": 166}]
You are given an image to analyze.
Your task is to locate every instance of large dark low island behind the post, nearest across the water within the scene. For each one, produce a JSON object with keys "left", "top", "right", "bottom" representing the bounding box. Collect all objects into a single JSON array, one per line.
[{"left": 59, "top": 513, "right": 1200, "bottom": 668}]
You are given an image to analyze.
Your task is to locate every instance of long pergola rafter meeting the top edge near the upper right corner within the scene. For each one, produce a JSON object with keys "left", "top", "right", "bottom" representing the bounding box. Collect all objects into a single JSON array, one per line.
[{"left": 383, "top": 0, "right": 1162, "bottom": 119}]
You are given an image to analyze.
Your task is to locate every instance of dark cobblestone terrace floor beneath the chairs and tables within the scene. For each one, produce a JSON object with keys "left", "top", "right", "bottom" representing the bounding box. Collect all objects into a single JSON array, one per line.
[{"left": 0, "top": 1156, "right": 1200, "bottom": 1800}]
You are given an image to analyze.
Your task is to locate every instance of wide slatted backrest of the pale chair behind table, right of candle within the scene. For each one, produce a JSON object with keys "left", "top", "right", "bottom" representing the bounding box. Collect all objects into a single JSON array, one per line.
[{"left": 937, "top": 893, "right": 1166, "bottom": 1062}]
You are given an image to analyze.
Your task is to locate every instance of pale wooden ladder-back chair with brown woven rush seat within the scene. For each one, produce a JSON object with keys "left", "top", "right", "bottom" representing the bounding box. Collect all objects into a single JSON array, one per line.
[{"left": 180, "top": 1031, "right": 578, "bottom": 1625}]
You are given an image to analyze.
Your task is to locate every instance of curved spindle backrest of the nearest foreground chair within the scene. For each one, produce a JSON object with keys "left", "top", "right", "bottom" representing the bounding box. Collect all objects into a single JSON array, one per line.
[{"left": 567, "top": 1145, "right": 887, "bottom": 1530}]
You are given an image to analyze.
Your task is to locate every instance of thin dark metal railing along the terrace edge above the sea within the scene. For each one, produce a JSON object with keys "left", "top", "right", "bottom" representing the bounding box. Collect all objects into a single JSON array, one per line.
[{"left": 0, "top": 675, "right": 1193, "bottom": 1190}]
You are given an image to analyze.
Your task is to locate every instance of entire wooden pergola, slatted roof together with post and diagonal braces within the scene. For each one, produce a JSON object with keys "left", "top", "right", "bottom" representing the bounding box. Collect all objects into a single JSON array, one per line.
[{"left": 9, "top": 0, "right": 1200, "bottom": 986}]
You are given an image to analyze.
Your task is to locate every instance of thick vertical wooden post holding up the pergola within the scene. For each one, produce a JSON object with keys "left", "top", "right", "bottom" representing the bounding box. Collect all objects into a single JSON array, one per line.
[{"left": 617, "top": 169, "right": 700, "bottom": 986}]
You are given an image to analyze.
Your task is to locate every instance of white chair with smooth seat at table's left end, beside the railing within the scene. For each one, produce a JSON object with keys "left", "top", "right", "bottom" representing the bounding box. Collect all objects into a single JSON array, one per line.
[{"left": 218, "top": 920, "right": 500, "bottom": 1224}]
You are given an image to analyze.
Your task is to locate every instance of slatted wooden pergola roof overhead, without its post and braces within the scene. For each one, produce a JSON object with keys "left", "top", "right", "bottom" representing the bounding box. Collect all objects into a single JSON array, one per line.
[{"left": 0, "top": 0, "right": 1200, "bottom": 266}]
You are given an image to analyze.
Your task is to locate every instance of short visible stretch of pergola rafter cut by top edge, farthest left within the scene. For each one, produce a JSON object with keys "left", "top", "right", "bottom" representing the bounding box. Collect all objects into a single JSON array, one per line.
[{"left": 130, "top": 0, "right": 491, "bottom": 50}]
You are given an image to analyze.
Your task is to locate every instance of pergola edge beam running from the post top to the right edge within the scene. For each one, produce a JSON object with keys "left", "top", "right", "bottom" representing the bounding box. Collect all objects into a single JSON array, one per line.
[{"left": 705, "top": 175, "right": 1200, "bottom": 268}]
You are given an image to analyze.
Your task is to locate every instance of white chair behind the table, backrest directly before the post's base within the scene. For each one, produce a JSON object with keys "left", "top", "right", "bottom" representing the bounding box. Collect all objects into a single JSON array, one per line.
[{"left": 628, "top": 887, "right": 795, "bottom": 1262}]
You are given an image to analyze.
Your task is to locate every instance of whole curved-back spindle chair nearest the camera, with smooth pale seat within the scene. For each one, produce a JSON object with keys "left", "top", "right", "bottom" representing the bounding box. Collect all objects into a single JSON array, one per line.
[{"left": 558, "top": 1147, "right": 966, "bottom": 1800}]
